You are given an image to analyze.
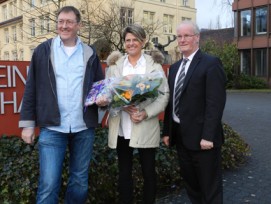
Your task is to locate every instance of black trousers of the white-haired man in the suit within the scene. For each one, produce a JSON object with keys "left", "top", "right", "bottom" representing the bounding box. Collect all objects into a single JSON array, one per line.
[{"left": 175, "top": 124, "right": 223, "bottom": 204}]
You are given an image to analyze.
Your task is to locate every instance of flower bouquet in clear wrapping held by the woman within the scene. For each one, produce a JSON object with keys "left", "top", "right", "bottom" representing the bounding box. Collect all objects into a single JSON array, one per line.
[{"left": 85, "top": 71, "right": 164, "bottom": 113}]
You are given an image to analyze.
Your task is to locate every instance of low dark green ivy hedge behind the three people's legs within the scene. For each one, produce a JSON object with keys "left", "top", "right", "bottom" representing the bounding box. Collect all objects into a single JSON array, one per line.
[{"left": 0, "top": 125, "right": 249, "bottom": 204}]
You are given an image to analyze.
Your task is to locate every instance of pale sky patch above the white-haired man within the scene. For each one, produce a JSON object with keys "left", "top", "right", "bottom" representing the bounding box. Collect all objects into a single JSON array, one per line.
[{"left": 196, "top": 0, "right": 233, "bottom": 29}]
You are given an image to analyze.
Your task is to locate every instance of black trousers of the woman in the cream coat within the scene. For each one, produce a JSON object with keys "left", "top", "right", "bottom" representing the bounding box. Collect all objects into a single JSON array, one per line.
[{"left": 117, "top": 137, "right": 156, "bottom": 204}]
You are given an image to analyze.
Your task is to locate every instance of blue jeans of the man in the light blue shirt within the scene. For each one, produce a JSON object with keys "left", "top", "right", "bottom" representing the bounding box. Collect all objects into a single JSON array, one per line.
[{"left": 37, "top": 128, "right": 94, "bottom": 204}]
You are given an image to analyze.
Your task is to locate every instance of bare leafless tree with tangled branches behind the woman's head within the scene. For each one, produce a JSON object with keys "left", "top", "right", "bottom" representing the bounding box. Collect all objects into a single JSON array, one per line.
[{"left": 92, "top": 0, "right": 162, "bottom": 52}]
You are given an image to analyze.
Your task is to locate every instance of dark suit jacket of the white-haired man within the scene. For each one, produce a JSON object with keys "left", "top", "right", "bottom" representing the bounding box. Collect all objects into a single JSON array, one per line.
[{"left": 163, "top": 50, "right": 226, "bottom": 150}]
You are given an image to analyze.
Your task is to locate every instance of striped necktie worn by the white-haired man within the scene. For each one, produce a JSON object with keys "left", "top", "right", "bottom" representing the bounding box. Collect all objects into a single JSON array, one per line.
[{"left": 174, "top": 58, "right": 188, "bottom": 117}]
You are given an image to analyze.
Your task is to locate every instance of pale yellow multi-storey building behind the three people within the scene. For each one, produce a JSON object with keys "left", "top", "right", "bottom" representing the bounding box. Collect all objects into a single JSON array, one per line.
[{"left": 0, "top": 0, "right": 196, "bottom": 61}]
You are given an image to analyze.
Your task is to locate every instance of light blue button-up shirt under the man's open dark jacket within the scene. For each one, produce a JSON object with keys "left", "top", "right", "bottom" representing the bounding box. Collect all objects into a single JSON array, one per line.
[{"left": 48, "top": 36, "right": 87, "bottom": 133}]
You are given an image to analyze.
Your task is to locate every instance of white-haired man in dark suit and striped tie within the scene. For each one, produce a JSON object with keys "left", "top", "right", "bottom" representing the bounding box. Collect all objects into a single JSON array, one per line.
[{"left": 163, "top": 21, "right": 226, "bottom": 204}]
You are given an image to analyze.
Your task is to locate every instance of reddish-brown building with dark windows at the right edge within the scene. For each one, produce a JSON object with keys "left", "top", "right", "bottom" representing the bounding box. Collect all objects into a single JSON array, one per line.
[{"left": 232, "top": 0, "right": 271, "bottom": 86}]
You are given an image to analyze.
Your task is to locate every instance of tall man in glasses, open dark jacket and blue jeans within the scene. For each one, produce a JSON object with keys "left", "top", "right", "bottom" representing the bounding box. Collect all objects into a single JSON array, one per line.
[{"left": 19, "top": 6, "right": 104, "bottom": 204}]
